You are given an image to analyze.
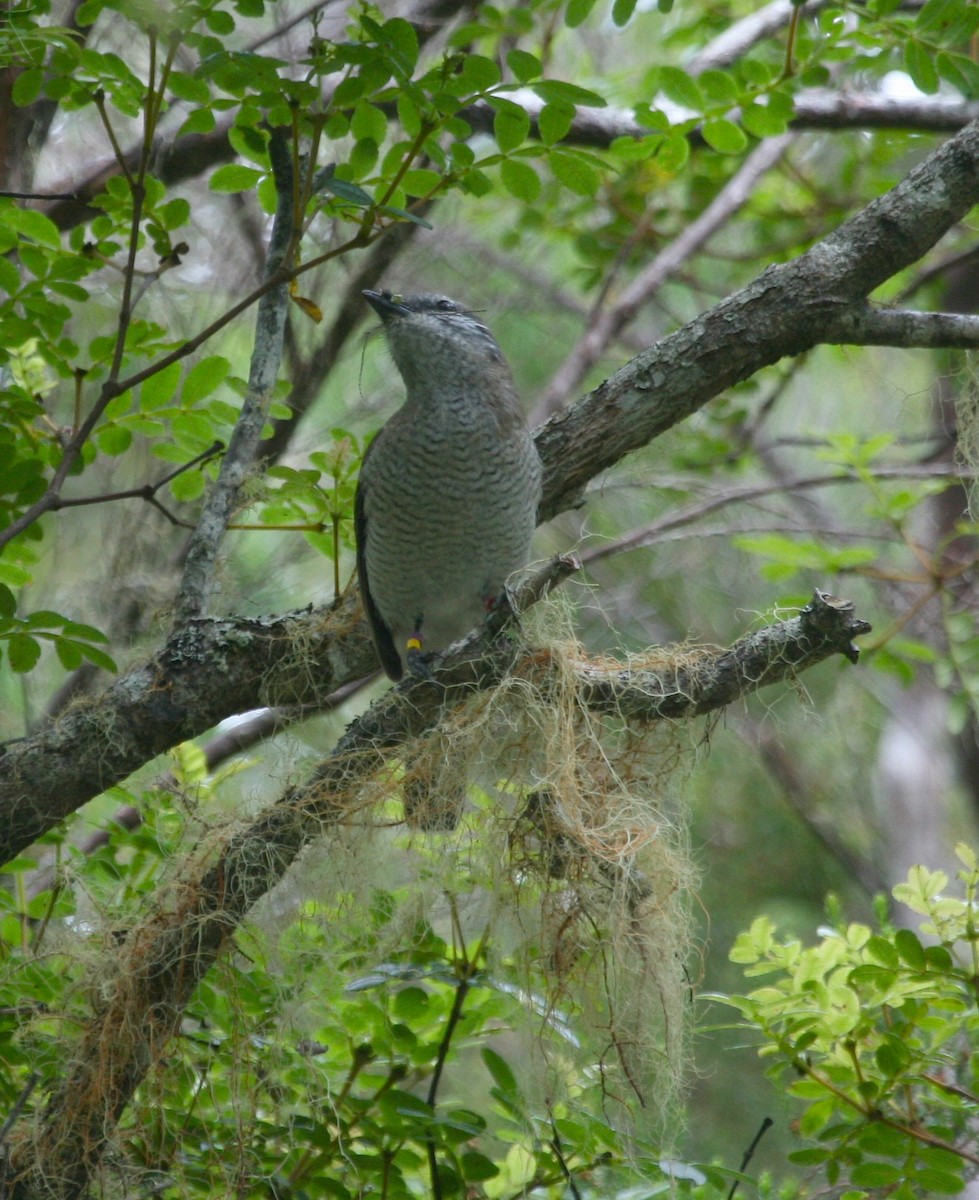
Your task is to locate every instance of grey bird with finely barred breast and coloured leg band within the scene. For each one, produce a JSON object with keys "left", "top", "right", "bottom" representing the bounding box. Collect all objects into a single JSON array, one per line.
[{"left": 354, "top": 292, "right": 541, "bottom": 679}]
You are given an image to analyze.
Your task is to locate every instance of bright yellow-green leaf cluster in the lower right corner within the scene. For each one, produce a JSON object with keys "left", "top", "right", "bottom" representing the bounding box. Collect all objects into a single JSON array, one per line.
[{"left": 714, "top": 845, "right": 979, "bottom": 1200}]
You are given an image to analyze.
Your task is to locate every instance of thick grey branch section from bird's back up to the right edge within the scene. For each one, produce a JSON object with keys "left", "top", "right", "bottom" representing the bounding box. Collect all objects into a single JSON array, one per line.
[{"left": 537, "top": 115, "right": 979, "bottom": 521}]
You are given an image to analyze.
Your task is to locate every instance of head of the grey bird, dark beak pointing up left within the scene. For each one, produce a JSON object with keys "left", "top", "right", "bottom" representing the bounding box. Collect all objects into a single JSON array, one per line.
[{"left": 364, "top": 292, "right": 510, "bottom": 395}]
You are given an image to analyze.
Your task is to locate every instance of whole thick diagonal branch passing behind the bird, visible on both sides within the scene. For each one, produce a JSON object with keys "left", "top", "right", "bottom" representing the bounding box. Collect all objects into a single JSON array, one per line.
[{"left": 0, "top": 124, "right": 979, "bottom": 862}]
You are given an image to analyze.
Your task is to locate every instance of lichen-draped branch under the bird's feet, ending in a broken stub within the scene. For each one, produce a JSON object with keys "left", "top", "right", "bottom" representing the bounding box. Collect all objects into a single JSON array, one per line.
[{"left": 11, "top": 588, "right": 870, "bottom": 1200}]
